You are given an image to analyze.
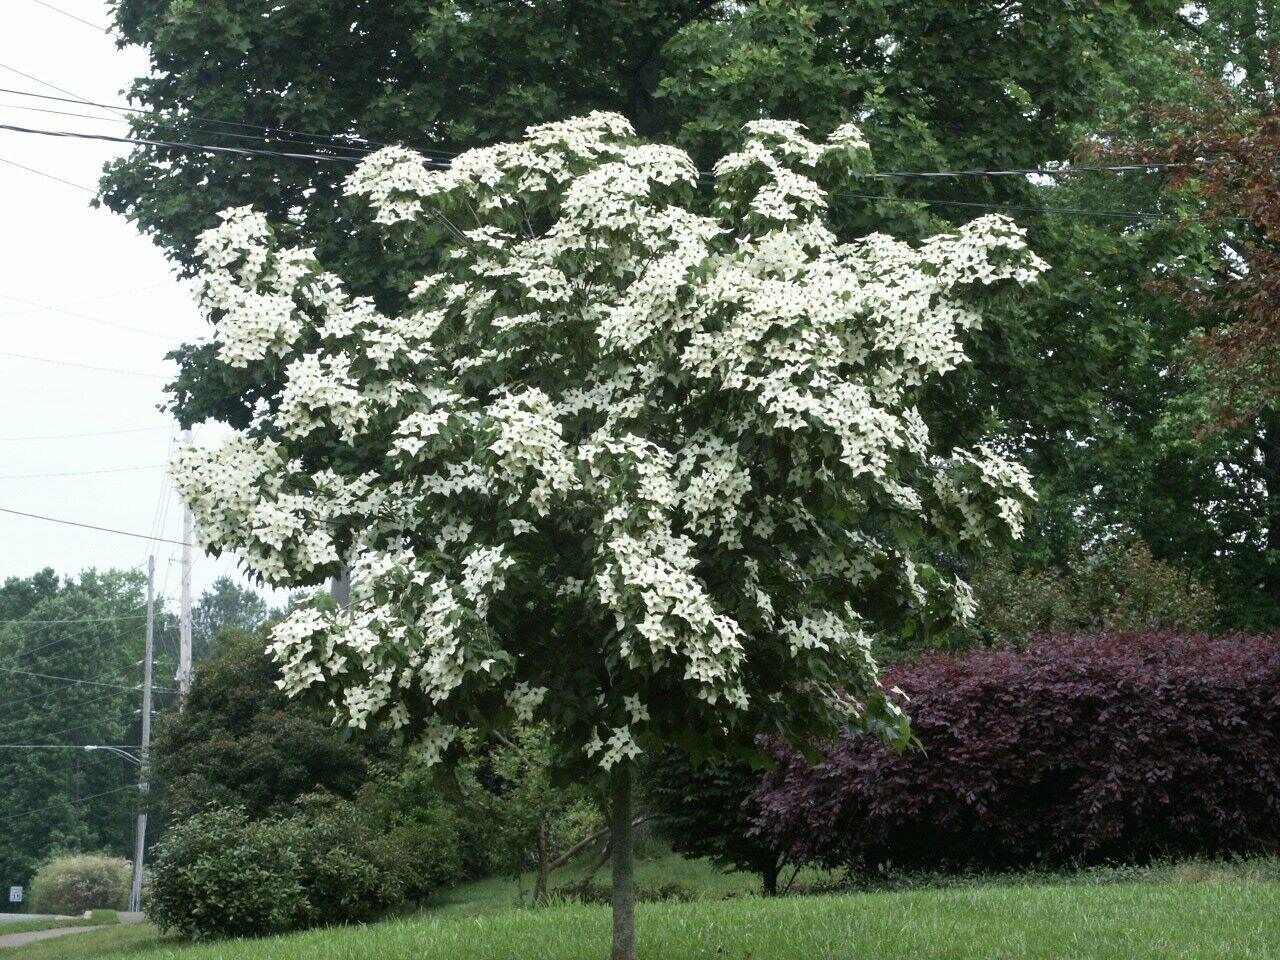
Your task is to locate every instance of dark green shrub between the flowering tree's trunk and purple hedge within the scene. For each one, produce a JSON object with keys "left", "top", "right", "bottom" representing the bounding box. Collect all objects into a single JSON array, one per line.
[{"left": 644, "top": 750, "right": 782, "bottom": 896}]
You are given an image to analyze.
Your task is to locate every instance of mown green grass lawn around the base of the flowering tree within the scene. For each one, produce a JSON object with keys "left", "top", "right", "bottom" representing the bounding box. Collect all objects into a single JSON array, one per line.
[{"left": 3, "top": 860, "right": 1280, "bottom": 960}]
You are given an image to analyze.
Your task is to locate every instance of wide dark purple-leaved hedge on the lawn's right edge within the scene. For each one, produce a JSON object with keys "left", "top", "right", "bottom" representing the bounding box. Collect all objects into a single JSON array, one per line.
[{"left": 748, "top": 634, "right": 1280, "bottom": 869}]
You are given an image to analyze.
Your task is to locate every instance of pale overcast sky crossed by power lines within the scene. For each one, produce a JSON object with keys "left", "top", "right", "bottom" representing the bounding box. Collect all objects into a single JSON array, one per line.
[{"left": 0, "top": 0, "right": 272, "bottom": 609}]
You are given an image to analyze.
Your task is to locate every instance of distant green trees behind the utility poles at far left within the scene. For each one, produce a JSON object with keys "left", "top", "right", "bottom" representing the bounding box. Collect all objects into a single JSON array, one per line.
[{"left": 0, "top": 570, "right": 159, "bottom": 884}]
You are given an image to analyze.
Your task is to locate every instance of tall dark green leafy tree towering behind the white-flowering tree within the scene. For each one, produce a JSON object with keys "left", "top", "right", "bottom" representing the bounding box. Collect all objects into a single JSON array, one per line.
[{"left": 102, "top": 0, "right": 1249, "bottom": 647}]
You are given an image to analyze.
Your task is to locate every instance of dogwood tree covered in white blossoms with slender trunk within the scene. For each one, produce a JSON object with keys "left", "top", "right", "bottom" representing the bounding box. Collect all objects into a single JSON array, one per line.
[{"left": 173, "top": 113, "right": 1042, "bottom": 957}]
